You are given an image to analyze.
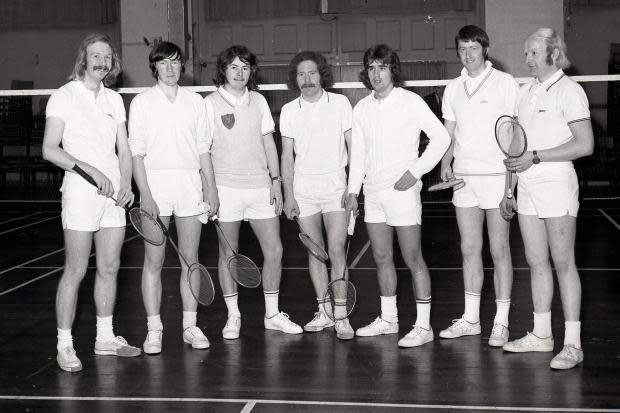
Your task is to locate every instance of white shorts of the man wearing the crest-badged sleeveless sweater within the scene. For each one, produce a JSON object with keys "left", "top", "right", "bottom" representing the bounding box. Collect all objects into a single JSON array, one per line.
[{"left": 217, "top": 185, "right": 276, "bottom": 222}]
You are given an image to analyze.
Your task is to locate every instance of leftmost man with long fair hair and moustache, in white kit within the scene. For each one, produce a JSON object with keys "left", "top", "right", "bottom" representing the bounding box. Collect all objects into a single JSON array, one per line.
[{"left": 43, "top": 34, "right": 140, "bottom": 372}]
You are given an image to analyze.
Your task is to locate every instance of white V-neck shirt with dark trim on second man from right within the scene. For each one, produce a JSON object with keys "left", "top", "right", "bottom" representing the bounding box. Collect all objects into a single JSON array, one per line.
[{"left": 442, "top": 61, "right": 519, "bottom": 174}]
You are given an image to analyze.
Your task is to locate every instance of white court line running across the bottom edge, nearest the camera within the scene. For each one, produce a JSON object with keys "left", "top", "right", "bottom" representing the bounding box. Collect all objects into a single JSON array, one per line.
[{"left": 0, "top": 395, "right": 620, "bottom": 413}]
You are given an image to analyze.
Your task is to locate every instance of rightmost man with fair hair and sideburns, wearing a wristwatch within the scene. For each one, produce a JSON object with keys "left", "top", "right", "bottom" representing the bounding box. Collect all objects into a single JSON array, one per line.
[{"left": 502, "top": 28, "right": 594, "bottom": 369}]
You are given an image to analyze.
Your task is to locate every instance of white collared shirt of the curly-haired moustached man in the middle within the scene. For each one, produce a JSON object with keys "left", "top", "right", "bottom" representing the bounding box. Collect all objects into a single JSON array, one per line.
[{"left": 280, "top": 90, "right": 353, "bottom": 175}]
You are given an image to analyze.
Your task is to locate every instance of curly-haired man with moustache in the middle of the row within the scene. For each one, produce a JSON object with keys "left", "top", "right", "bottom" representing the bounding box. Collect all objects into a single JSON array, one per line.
[{"left": 280, "top": 51, "right": 354, "bottom": 340}]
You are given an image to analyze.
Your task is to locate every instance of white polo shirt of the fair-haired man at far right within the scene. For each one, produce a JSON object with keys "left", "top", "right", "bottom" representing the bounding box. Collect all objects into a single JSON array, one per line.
[{"left": 517, "top": 70, "right": 590, "bottom": 176}]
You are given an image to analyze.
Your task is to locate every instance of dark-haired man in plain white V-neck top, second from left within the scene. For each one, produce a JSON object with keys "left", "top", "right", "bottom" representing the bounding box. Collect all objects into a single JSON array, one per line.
[{"left": 129, "top": 42, "right": 217, "bottom": 354}]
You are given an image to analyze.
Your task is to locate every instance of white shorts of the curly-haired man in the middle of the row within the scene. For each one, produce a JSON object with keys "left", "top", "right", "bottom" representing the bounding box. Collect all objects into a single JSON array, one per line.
[{"left": 293, "top": 169, "right": 347, "bottom": 217}]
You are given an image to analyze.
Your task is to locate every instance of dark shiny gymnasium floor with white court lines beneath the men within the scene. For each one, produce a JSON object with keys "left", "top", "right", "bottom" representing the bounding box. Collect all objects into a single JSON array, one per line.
[{"left": 0, "top": 197, "right": 620, "bottom": 413}]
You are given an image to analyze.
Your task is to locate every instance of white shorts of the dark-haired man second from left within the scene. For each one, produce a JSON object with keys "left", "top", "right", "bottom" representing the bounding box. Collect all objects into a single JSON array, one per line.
[{"left": 146, "top": 169, "right": 202, "bottom": 217}]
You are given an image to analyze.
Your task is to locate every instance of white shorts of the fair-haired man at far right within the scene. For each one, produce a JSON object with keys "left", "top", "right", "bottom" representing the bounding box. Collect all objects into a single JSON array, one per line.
[{"left": 517, "top": 168, "right": 579, "bottom": 218}]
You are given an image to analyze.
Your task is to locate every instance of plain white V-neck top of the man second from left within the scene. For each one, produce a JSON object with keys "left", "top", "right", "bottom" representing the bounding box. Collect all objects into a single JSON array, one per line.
[{"left": 129, "top": 85, "right": 211, "bottom": 170}]
